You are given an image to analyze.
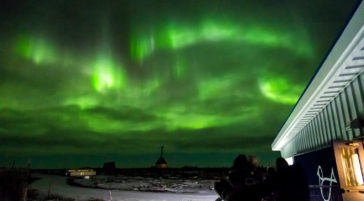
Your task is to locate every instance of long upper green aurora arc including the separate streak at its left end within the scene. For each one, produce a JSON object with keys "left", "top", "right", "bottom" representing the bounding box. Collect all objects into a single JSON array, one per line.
[{"left": 130, "top": 20, "right": 313, "bottom": 57}]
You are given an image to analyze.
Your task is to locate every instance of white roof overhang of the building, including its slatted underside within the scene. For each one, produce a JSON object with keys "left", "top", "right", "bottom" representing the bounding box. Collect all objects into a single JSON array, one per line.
[{"left": 272, "top": 2, "right": 364, "bottom": 151}]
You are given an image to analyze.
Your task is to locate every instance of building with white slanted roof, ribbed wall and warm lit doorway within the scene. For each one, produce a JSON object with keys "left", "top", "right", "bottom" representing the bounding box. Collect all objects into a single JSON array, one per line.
[{"left": 272, "top": 2, "right": 364, "bottom": 201}]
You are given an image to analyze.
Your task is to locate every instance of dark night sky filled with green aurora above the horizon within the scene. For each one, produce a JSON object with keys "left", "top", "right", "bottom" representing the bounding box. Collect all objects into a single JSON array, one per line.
[{"left": 0, "top": 0, "right": 357, "bottom": 168}]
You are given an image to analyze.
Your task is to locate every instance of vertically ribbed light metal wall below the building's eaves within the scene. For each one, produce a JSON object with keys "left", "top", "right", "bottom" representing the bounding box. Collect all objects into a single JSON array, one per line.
[{"left": 281, "top": 73, "right": 364, "bottom": 157}]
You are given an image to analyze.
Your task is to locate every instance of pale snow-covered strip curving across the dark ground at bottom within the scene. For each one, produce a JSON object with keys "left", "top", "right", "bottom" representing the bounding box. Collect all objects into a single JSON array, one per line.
[{"left": 31, "top": 174, "right": 217, "bottom": 201}]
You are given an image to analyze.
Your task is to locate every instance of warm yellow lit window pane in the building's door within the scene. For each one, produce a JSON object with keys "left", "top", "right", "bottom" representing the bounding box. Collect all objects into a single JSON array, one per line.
[{"left": 340, "top": 147, "right": 364, "bottom": 186}]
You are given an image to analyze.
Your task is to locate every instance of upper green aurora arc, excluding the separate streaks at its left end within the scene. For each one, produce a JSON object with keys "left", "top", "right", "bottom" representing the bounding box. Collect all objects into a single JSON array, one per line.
[{"left": 169, "top": 21, "right": 311, "bottom": 54}]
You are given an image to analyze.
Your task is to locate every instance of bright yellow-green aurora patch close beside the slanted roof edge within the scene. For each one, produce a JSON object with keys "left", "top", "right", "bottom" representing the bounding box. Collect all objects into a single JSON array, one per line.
[{"left": 259, "top": 77, "right": 304, "bottom": 104}]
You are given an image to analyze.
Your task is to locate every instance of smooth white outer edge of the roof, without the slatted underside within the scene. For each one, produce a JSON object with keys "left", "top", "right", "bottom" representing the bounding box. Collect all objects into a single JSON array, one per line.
[{"left": 272, "top": 2, "right": 364, "bottom": 151}]
